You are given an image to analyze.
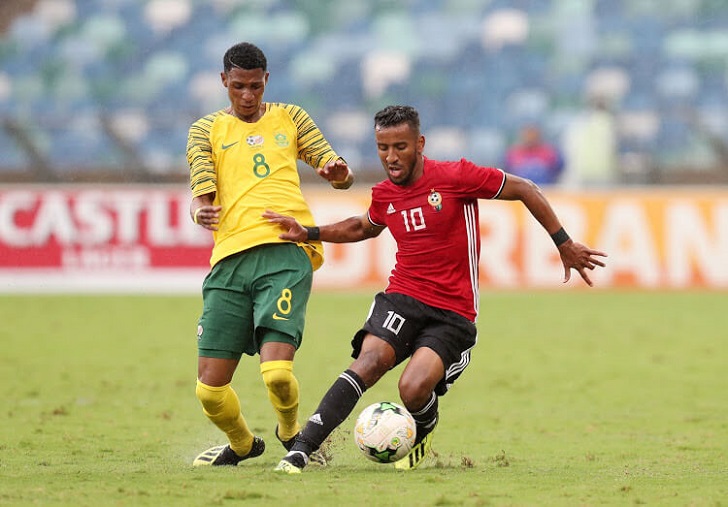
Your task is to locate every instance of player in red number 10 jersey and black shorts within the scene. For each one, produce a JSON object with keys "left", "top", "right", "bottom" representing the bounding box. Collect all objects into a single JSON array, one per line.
[{"left": 264, "top": 106, "right": 606, "bottom": 473}]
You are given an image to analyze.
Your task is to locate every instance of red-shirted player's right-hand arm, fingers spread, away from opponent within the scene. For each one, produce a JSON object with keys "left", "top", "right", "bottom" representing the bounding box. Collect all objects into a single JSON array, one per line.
[{"left": 498, "top": 174, "right": 607, "bottom": 287}]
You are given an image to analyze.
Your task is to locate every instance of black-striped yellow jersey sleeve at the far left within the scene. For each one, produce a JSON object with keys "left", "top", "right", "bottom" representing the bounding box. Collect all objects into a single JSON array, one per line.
[{"left": 187, "top": 114, "right": 217, "bottom": 197}]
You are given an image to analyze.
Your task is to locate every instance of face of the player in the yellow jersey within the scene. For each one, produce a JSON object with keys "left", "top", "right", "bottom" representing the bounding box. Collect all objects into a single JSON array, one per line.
[{"left": 221, "top": 67, "right": 268, "bottom": 122}]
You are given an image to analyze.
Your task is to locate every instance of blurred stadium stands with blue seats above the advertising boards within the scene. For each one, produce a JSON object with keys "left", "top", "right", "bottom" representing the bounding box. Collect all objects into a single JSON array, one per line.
[{"left": 0, "top": 0, "right": 728, "bottom": 187}]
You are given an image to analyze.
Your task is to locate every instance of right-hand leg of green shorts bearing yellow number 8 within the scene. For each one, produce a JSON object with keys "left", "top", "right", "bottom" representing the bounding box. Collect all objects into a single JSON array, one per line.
[{"left": 252, "top": 244, "right": 313, "bottom": 348}]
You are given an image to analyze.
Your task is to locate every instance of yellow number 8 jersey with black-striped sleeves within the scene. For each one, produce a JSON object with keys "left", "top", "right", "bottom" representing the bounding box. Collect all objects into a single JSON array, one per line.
[{"left": 187, "top": 103, "right": 338, "bottom": 269}]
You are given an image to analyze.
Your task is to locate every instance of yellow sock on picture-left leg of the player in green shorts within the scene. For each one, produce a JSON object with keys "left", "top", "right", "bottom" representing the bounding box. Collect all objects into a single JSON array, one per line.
[{"left": 195, "top": 380, "right": 253, "bottom": 456}]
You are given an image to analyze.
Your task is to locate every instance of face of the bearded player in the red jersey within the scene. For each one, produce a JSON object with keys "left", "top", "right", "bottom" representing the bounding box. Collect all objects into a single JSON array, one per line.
[{"left": 374, "top": 123, "right": 425, "bottom": 186}]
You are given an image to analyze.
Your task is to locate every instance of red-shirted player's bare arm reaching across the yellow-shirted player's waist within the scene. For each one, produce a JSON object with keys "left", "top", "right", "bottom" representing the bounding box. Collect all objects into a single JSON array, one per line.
[{"left": 262, "top": 210, "right": 384, "bottom": 243}]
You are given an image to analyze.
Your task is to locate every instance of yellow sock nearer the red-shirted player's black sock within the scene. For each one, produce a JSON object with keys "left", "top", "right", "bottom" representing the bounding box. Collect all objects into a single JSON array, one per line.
[{"left": 260, "top": 361, "right": 301, "bottom": 440}]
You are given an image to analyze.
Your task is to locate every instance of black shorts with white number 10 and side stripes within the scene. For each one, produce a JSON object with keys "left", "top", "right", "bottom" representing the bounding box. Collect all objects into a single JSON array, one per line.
[{"left": 351, "top": 292, "right": 478, "bottom": 396}]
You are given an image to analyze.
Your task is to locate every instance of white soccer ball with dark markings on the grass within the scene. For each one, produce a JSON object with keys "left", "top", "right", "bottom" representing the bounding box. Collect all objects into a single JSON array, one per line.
[{"left": 354, "top": 401, "right": 417, "bottom": 463}]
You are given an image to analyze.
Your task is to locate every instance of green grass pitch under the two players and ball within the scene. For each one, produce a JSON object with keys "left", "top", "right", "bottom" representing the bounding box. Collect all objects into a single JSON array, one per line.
[{"left": 0, "top": 291, "right": 728, "bottom": 506}]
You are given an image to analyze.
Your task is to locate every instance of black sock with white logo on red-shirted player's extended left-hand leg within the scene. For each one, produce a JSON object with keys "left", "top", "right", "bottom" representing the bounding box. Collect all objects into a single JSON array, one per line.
[{"left": 291, "top": 370, "right": 366, "bottom": 455}]
